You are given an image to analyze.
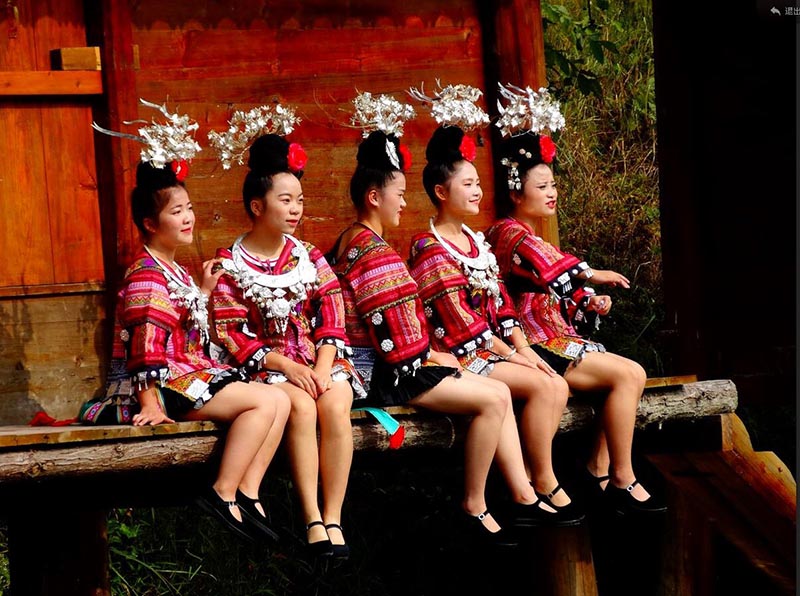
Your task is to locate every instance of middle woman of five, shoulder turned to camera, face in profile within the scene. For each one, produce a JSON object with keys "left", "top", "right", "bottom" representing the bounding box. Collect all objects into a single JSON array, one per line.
[{"left": 329, "top": 93, "right": 555, "bottom": 546}]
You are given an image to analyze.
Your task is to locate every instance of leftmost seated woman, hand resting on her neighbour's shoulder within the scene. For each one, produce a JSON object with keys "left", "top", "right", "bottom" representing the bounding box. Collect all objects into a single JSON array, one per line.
[{"left": 81, "top": 102, "right": 290, "bottom": 540}]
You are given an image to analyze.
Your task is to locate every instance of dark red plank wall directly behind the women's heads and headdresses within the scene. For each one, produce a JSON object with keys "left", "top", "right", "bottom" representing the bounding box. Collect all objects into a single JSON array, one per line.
[{"left": 118, "top": 0, "right": 492, "bottom": 272}]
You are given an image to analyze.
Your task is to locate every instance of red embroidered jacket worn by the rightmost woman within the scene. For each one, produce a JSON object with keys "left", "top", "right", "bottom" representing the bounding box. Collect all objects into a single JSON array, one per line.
[{"left": 486, "top": 218, "right": 597, "bottom": 344}]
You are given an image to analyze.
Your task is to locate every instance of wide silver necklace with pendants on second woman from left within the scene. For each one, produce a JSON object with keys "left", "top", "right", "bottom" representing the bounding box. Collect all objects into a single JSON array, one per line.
[{"left": 222, "top": 234, "right": 317, "bottom": 333}]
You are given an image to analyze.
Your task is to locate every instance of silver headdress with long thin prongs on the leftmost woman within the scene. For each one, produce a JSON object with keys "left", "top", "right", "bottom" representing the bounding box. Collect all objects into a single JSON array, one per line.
[{"left": 92, "top": 98, "right": 201, "bottom": 168}]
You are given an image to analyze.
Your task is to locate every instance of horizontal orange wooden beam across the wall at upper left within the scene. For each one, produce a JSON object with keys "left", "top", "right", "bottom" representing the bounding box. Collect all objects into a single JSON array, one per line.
[{"left": 0, "top": 70, "right": 103, "bottom": 96}]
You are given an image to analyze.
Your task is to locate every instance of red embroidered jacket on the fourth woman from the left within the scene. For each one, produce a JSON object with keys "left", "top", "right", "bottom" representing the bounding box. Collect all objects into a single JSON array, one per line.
[{"left": 409, "top": 232, "right": 518, "bottom": 366}]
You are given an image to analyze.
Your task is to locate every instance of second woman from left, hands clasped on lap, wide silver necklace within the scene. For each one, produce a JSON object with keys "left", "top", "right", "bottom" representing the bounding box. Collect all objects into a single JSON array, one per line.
[{"left": 212, "top": 106, "right": 363, "bottom": 559}]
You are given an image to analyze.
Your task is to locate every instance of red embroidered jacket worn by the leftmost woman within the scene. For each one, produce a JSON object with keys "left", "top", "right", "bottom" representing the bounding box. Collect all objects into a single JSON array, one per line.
[{"left": 112, "top": 250, "right": 231, "bottom": 406}]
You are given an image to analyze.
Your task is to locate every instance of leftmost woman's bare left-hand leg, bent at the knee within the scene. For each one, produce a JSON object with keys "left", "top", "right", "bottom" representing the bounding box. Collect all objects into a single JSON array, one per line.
[{"left": 184, "top": 382, "right": 288, "bottom": 521}]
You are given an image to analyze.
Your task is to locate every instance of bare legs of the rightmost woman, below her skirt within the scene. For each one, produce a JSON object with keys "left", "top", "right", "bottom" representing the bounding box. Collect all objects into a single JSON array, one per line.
[{"left": 564, "top": 352, "right": 650, "bottom": 501}]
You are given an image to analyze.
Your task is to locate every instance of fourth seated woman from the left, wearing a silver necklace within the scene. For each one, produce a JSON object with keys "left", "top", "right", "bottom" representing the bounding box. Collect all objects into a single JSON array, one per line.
[{"left": 409, "top": 85, "right": 584, "bottom": 525}]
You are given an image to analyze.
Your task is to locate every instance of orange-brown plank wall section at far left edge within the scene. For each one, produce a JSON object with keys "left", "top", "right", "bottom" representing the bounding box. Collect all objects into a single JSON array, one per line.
[{"left": 0, "top": 0, "right": 106, "bottom": 424}]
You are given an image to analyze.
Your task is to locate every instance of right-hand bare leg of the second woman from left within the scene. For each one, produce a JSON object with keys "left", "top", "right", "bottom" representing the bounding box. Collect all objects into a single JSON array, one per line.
[{"left": 317, "top": 381, "right": 353, "bottom": 544}]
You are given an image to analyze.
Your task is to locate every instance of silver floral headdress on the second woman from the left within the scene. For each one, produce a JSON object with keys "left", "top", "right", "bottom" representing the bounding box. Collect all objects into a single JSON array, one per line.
[{"left": 208, "top": 104, "right": 300, "bottom": 170}]
